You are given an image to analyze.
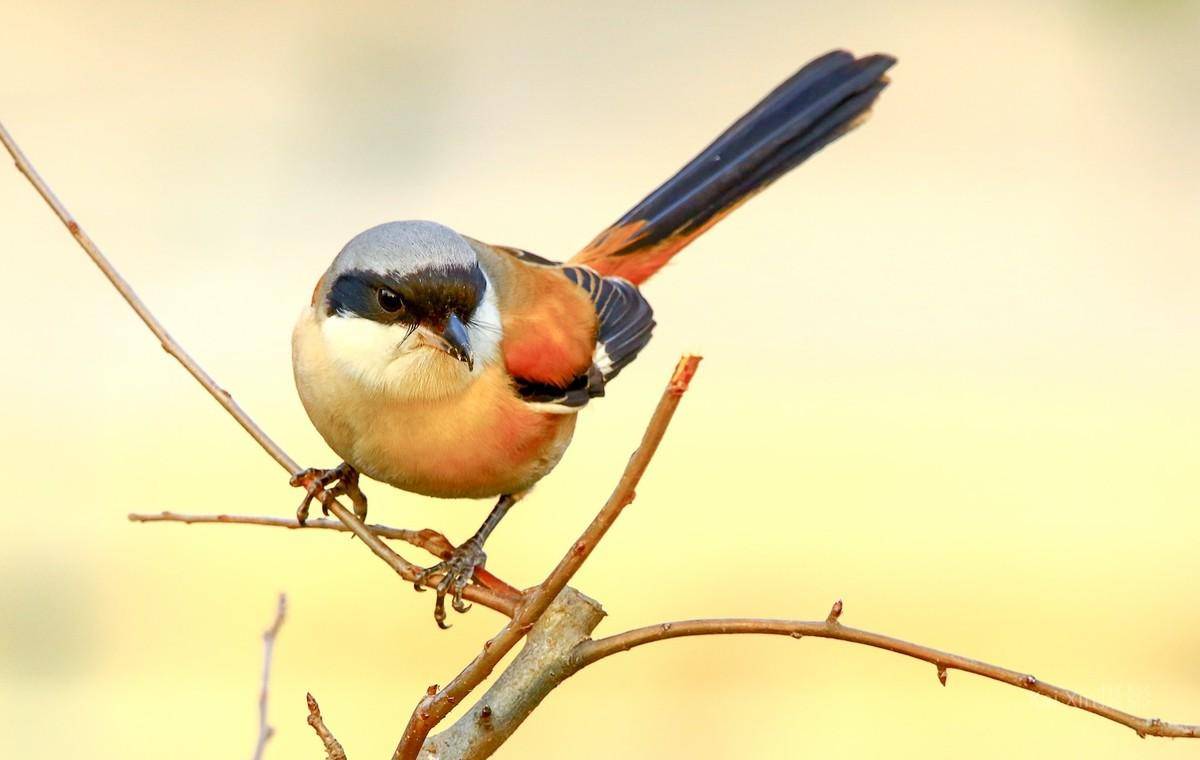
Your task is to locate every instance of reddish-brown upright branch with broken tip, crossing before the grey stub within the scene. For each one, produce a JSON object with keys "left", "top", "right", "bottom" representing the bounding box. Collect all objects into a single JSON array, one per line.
[{"left": 392, "top": 355, "right": 700, "bottom": 760}]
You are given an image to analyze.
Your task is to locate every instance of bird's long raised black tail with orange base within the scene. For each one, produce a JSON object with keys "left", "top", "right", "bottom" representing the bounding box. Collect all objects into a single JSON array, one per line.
[{"left": 571, "top": 50, "right": 895, "bottom": 283}]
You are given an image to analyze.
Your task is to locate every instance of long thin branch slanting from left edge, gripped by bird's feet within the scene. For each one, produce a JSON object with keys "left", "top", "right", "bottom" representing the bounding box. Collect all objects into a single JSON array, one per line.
[{"left": 0, "top": 118, "right": 512, "bottom": 615}]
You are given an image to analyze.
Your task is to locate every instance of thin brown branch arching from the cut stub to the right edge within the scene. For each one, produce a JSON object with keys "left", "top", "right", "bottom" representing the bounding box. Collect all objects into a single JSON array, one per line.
[{"left": 572, "top": 600, "right": 1200, "bottom": 738}]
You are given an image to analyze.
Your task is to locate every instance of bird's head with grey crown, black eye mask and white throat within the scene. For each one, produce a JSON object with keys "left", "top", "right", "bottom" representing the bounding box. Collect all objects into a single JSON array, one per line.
[{"left": 313, "top": 221, "right": 500, "bottom": 399}]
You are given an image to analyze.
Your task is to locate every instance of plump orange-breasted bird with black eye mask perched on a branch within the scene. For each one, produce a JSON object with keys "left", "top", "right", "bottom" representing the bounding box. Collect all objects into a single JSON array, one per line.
[{"left": 292, "top": 50, "right": 895, "bottom": 628}]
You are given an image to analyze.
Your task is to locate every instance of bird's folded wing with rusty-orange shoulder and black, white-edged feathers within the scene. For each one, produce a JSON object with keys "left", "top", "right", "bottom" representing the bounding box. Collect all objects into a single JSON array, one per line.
[{"left": 476, "top": 244, "right": 654, "bottom": 412}]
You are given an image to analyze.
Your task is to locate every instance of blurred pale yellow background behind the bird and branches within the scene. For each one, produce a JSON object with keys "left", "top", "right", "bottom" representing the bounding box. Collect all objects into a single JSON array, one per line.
[{"left": 0, "top": 0, "right": 1200, "bottom": 760}]
